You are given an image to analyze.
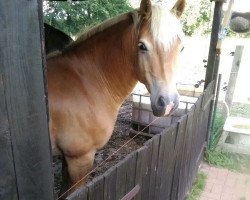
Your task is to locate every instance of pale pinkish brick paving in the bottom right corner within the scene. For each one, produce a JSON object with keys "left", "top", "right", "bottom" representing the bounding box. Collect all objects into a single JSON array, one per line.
[{"left": 199, "top": 163, "right": 250, "bottom": 200}]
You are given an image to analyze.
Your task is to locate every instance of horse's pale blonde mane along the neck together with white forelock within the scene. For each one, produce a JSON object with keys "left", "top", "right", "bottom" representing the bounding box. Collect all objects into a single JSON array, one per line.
[{"left": 61, "top": 5, "right": 184, "bottom": 52}]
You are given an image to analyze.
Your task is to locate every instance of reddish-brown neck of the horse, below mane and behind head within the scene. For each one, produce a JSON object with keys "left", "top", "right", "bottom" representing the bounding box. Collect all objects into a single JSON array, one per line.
[{"left": 67, "top": 18, "right": 137, "bottom": 108}]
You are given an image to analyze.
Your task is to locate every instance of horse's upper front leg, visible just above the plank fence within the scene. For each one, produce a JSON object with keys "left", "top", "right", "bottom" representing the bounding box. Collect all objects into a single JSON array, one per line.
[{"left": 65, "top": 151, "right": 96, "bottom": 192}]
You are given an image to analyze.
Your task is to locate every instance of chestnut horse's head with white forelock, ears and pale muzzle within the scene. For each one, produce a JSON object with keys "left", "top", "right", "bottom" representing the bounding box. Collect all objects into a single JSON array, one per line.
[{"left": 137, "top": 0, "right": 185, "bottom": 116}]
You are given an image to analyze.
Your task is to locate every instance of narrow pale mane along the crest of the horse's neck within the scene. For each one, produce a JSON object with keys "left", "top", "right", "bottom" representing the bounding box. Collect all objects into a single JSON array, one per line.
[{"left": 64, "top": 10, "right": 139, "bottom": 50}]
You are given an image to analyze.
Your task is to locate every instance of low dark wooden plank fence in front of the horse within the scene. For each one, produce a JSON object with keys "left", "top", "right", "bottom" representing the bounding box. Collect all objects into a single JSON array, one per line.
[{"left": 66, "top": 83, "right": 213, "bottom": 200}]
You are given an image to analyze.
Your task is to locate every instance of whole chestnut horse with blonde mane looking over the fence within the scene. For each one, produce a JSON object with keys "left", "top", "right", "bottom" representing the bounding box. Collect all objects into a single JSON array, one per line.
[{"left": 47, "top": 0, "right": 185, "bottom": 193}]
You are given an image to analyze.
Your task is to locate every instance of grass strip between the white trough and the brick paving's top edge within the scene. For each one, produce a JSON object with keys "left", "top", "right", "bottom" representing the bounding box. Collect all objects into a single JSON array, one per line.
[{"left": 205, "top": 150, "right": 250, "bottom": 172}]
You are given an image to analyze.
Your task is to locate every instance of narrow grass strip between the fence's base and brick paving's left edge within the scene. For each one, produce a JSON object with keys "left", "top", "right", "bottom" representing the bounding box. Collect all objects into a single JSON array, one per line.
[{"left": 185, "top": 172, "right": 207, "bottom": 200}]
